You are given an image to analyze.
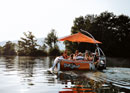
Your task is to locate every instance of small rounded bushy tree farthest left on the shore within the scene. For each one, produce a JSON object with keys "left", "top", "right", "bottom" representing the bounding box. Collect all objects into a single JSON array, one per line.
[{"left": 1, "top": 41, "right": 16, "bottom": 55}]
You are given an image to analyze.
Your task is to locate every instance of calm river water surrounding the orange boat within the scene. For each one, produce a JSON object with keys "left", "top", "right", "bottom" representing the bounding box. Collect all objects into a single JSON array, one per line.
[{"left": 0, "top": 56, "right": 130, "bottom": 93}]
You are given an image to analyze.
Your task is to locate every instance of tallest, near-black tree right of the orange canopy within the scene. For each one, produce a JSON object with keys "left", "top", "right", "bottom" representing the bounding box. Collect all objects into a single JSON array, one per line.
[{"left": 90, "top": 12, "right": 130, "bottom": 56}]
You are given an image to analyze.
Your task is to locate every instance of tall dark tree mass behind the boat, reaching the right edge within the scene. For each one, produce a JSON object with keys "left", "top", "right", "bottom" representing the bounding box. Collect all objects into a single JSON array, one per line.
[{"left": 65, "top": 12, "right": 130, "bottom": 56}]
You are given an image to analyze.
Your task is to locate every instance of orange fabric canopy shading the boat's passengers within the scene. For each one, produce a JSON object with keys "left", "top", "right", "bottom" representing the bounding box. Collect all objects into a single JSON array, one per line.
[{"left": 59, "top": 32, "right": 101, "bottom": 43}]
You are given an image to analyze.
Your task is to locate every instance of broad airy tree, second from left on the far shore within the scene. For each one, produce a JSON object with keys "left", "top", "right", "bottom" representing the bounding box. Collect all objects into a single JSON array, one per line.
[{"left": 18, "top": 31, "right": 37, "bottom": 56}]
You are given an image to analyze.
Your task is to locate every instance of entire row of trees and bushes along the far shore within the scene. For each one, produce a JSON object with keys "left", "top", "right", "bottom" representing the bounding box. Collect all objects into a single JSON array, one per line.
[{"left": 0, "top": 11, "right": 130, "bottom": 57}]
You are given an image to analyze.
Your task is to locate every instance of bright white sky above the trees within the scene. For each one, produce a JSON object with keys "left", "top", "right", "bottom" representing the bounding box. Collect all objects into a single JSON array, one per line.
[{"left": 0, "top": 0, "right": 130, "bottom": 41}]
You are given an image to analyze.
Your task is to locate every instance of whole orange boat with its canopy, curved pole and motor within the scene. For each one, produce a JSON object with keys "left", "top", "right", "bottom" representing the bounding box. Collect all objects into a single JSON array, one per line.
[{"left": 50, "top": 30, "right": 106, "bottom": 71}]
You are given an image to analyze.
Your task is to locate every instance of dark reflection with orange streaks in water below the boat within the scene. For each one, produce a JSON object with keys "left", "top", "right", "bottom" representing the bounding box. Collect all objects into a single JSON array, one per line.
[{"left": 57, "top": 73, "right": 105, "bottom": 93}]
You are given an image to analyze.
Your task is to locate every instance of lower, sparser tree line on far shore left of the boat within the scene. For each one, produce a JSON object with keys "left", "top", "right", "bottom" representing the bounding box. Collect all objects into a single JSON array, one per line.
[{"left": 0, "top": 29, "right": 61, "bottom": 56}]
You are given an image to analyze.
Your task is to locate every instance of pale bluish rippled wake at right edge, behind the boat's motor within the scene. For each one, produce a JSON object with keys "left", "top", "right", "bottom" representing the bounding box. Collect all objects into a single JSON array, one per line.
[{"left": 103, "top": 67, "right": 130, "bottom": 89}]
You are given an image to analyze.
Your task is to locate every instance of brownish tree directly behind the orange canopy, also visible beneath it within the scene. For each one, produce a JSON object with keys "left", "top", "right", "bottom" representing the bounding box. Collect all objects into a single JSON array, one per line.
[{"left": 64, "top": 15, "right": 96, "bottom": 53}]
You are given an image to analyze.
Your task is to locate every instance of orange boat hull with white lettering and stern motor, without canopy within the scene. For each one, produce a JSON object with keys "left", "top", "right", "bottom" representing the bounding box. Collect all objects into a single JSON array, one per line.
[{"left": 57, "top": 47, "right": 106, "bottom": 71}]
